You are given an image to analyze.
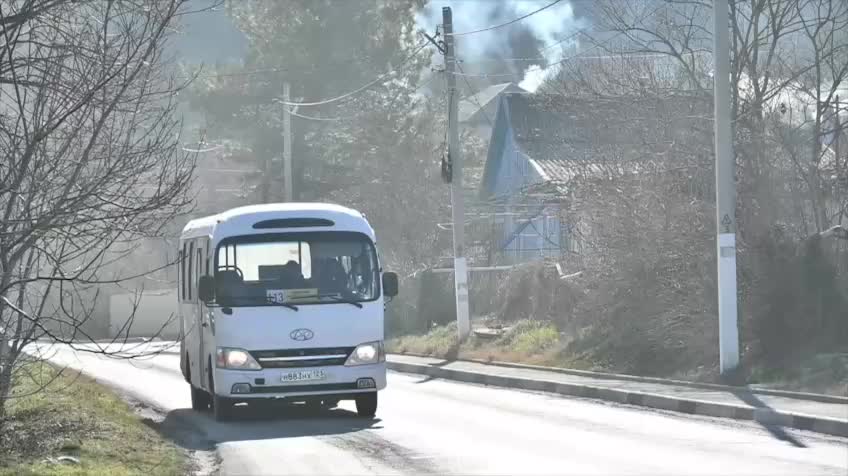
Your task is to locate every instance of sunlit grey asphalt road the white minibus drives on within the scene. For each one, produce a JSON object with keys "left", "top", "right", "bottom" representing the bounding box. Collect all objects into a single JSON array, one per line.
[{"left": 31, "top": 348, "right": 848, "bottom": 476}]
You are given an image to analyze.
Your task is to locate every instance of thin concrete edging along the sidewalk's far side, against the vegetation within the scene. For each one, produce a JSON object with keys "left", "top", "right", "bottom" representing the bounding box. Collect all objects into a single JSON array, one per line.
[{"left": 395, "top": 352, "right": 848, "bottom": 405}]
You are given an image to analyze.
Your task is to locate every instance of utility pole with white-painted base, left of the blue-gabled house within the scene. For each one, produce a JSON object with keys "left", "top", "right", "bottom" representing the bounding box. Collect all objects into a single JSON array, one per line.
[{"left": 442, "top": 7, "right": 471, "bottom": 342}]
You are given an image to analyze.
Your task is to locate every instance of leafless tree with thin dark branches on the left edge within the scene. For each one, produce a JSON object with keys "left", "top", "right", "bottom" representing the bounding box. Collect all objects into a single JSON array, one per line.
[{"left": 0, "top": 0, "right": 194, "bottom": 423}]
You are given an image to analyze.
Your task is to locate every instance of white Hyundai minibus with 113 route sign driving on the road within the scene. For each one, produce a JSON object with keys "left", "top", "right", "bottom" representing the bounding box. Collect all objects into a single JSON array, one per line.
[{"left": 178, "top": 203, "right": 398, "bottom": 420}]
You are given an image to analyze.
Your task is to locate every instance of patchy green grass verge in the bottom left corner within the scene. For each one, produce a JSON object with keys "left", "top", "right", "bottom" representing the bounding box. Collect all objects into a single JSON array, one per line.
[{"left": 0, "top": 363, "right": 188, "bottom": 476}]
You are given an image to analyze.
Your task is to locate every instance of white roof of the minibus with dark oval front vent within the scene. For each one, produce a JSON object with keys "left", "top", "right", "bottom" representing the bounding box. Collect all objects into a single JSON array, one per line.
[{"left": 181, "top": 203, "right": 375, "bottom": 243}]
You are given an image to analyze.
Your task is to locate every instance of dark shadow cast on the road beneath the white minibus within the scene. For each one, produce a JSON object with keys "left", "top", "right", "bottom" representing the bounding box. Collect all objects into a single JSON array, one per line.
[{"left": 145, "top": 404, "right": 382, "bottom": 451}]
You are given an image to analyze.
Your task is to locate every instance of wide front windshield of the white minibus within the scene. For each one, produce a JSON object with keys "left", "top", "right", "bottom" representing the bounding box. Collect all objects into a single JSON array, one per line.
[{"left": 215, "top": 231, "right": 380, "bottom": 307}]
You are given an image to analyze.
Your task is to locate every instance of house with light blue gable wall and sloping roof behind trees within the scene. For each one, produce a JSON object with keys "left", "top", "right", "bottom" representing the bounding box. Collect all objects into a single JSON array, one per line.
[{"left": 469, "top": 93, "right": 712, "bottom": 264}]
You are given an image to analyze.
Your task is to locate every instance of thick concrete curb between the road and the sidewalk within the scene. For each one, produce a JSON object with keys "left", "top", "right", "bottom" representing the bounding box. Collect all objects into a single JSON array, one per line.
[{"left": 386, "top": 361, "right": 848, "bottom": 437}]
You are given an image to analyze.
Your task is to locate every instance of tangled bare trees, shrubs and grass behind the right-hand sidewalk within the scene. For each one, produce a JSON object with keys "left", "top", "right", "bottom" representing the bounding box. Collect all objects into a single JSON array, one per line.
[{"left": 382, "top": 0, "right": 848, "bottom": 395}]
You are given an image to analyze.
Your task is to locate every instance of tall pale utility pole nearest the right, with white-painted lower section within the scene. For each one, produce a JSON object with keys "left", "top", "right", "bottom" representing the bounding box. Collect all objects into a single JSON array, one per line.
[{"left": 713, "top": 0, "right": 739, "bottom": 379}]
